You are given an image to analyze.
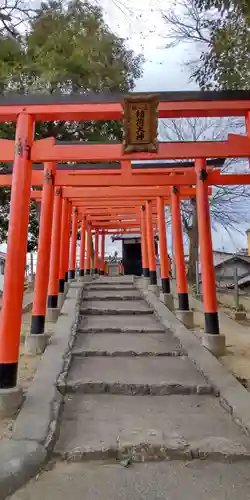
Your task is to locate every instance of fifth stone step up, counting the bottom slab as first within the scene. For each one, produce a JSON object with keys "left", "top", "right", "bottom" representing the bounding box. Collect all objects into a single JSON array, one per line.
[{"left": 78, "top": 314, "right": 165, "bottom": 333}]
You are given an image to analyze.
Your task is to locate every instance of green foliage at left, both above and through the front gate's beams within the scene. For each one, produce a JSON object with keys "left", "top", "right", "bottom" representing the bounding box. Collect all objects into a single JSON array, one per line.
[{"left": 0, "top": 0, "right": 142, "bottom": 245}]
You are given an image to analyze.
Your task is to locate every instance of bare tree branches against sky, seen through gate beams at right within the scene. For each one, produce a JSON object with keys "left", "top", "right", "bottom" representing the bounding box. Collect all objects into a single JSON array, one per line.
[{"left": 159, "top": 118, "right": 250, "bottom": 282}]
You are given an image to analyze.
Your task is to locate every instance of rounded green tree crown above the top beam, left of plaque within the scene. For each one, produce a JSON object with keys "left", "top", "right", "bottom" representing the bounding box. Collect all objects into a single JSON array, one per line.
[{"left": 5, "top": 0, "right": 141, "bottom": 93}]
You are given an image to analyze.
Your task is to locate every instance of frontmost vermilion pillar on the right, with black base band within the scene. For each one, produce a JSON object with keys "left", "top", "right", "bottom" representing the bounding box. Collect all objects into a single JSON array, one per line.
[{"left": 195, "top": 159, "right": 219, "bottom": 334}]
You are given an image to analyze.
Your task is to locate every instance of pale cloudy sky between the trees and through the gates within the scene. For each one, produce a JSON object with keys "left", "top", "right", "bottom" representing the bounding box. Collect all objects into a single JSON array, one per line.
[{"left": 2, "top": 0, "right": 250, "bottom": 254}]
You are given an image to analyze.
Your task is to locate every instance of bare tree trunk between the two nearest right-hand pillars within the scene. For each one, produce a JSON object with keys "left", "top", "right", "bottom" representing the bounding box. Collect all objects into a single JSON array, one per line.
[{"left": 187, "top": 198, "right": 199, "bottom": 285}]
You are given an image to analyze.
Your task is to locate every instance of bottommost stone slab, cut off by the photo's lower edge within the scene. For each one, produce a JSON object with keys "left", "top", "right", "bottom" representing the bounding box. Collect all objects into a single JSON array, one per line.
[{"left": 11, "top": 460, "right": 249, "bottom": 500}]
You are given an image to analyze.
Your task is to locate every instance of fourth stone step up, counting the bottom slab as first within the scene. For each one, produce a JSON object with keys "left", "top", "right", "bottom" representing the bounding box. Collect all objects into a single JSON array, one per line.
[{"left": 73, "top": 333, "right": 185, "bottom": 356}]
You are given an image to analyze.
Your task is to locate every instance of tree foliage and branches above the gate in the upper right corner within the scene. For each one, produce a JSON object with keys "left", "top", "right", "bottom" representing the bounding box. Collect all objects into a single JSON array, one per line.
[{"left": 163, "top": 0, "right": 250, "bottom": 90}]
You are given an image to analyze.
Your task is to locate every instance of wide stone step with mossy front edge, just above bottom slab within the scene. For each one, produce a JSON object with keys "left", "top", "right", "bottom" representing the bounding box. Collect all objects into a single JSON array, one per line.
[{"left": 55, "top": 394, "right": 250, "bottom": 460}]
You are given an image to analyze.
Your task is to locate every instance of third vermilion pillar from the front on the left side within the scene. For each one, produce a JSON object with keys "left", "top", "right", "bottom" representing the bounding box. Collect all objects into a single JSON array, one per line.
[{"left": 48, "top": 188, "right": 62, "bottom": 309}]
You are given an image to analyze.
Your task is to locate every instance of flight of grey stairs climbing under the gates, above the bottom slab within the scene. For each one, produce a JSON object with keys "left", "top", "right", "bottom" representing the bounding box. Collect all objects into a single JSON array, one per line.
[{"left": 55, "top": 277, "right": 250, "bottom": 462}]
